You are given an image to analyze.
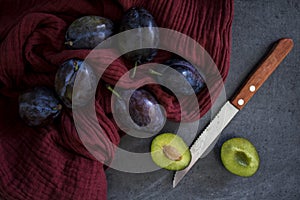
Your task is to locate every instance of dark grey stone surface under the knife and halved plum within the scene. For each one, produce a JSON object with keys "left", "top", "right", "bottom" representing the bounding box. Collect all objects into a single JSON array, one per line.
[{"left": 106, "top": 0, "right": 300, "bottom": 200}]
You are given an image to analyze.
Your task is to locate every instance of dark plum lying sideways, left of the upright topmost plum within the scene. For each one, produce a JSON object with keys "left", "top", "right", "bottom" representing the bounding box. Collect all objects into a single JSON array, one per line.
[{"left": 65, "top": 16, "right": 114, "bottom": 49}]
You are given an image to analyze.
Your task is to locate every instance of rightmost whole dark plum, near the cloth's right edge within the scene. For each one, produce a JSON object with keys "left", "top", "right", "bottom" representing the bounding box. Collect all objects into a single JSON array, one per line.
[{"left": 156, "top": 59, "right": 205, "bottom": 96}]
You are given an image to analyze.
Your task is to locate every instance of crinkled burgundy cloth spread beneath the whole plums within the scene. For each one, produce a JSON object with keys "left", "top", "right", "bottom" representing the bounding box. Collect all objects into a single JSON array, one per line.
[{"left": 0, "top": 0, "right": 233, "bottom": 200}]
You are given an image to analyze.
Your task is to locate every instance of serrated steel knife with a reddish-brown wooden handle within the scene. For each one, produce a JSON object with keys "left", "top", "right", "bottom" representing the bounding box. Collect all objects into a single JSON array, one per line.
[{"left": 173, "top": 38, "right": 293, "bottom": 188}]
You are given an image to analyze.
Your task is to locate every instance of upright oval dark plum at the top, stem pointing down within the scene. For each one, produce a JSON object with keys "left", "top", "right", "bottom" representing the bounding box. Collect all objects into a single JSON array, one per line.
[{"left": 118, "top": 7, "right": 159, "bottom": 64}]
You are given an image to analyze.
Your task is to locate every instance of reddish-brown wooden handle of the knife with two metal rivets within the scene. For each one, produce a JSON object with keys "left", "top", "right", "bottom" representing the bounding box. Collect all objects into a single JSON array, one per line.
[{"left": 231, "top": 38, "right": 293, "bottom": 110}]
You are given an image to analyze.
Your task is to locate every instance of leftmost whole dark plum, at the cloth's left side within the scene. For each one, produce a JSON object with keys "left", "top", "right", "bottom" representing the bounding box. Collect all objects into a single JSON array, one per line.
[{"left": 19, "top": 87, "right": 62, "bottom": 126}]
